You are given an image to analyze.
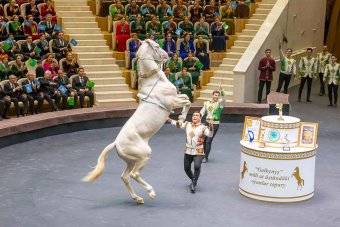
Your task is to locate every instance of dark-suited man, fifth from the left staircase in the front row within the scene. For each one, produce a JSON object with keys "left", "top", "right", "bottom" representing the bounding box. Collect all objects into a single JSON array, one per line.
[{"left": 4, "top": 75, "right": 28, "bottom": 117}]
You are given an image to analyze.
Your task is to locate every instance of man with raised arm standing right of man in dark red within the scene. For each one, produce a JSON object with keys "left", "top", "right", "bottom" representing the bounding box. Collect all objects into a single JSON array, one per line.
[{"left": 276, "top": 41, "right": 296, "bottom": 94}]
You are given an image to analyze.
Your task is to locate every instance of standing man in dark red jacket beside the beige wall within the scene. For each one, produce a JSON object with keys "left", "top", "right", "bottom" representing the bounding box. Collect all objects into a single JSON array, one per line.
[{"left": 257, "top": 49, "right": 276, "bottom": 103}]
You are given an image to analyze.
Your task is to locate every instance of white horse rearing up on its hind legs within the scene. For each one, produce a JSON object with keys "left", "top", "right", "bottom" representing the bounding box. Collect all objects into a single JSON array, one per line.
[{"left": 83, "top": 39, "right": 191, "bottom": 204}]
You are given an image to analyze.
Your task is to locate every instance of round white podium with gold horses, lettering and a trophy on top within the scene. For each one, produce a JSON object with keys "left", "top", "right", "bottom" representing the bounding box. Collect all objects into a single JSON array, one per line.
[{"left": 239, "top": 104, "right": 318, "bottom": 203}]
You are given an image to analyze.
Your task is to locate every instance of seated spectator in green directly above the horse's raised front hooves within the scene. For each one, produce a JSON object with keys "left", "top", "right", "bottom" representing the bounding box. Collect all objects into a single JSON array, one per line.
[{"left": 175, "top": 67, "right": 194, "bottom": 102}]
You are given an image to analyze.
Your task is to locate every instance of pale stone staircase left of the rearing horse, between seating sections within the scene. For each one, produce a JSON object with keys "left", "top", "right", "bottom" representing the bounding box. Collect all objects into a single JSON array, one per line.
[{"left": 54, "top": 0, "right": 136, "bottom": 106}]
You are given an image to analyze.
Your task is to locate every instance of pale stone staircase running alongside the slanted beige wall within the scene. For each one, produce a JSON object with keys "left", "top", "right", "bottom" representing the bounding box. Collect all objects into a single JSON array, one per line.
[{"left": 197, "top": 0, "right": 277, "bottom": 103}]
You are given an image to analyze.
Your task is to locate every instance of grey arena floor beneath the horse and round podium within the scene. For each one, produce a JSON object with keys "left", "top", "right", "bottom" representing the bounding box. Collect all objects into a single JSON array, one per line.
[{"left": 0, "top": 86, "right": 340, "bottom": 227}]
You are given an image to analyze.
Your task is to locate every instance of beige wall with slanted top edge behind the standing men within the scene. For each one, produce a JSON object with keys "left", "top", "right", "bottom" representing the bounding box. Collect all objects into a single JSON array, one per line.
[{"left": 234, "top": 0, "right": 326, "bottom": 102}]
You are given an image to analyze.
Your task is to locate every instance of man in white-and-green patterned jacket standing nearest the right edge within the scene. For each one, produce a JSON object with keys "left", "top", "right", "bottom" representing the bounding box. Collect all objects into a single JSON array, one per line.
[{"left": 323, "top": 55, "right": 340, "bottom": 107}]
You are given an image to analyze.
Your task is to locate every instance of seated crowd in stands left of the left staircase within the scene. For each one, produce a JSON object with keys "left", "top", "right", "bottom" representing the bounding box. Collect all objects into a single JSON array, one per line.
[{"left": 0, "top": 0, "right": 94, "bottom": 120}]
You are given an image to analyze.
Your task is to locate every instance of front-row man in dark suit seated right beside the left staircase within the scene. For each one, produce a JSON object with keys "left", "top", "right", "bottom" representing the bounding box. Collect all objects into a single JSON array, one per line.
[{"left": 72, "top": 67, "right": 94, "bottom": 108}]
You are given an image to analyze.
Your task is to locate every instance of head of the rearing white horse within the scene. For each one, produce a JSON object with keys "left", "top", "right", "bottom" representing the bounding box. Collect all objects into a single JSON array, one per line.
[{"left": 136, "top": 39, "right": 169, "bottom": 63}]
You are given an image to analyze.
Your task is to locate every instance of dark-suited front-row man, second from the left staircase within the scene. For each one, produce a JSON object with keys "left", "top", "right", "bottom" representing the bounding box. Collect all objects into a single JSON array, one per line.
[{"left": 54, "top": 70, "right": 78, "bottom": 110}]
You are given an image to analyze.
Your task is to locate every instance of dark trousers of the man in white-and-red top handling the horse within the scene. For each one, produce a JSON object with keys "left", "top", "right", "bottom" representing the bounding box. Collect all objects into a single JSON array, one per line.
[{"left": 184, "top": 154, "right": 204, "bottom": 185}]
